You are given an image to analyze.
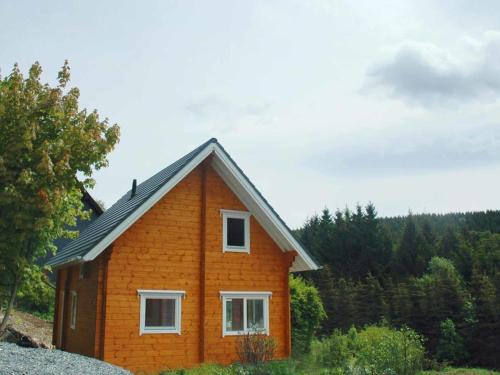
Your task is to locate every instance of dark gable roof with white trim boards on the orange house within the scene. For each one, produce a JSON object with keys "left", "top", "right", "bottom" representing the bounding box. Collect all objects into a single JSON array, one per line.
[{"left": 47, "top": 138, "right": 319, "bottom": 271}]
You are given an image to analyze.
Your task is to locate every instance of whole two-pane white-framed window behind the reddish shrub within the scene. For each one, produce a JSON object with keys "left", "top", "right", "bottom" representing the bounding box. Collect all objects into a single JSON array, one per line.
[{"left": 220, "top": 292, "right": 272, "bottom": 336}]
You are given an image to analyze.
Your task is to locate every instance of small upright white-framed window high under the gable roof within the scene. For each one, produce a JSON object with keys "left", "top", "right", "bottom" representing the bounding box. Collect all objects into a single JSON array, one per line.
[{"left": 221, "top": 210, "right": 251, "bottom": 253}]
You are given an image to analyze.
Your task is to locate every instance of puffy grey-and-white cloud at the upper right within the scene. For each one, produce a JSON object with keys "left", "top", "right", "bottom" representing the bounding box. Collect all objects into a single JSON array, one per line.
[{"left": 367, "top": 32, "right": 500, "bottom": 106}]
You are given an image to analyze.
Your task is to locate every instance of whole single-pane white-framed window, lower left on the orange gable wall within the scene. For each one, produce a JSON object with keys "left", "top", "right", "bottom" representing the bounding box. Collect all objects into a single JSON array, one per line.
[{"left": 137, "top": 289, "right": 186, "bottom": 335}]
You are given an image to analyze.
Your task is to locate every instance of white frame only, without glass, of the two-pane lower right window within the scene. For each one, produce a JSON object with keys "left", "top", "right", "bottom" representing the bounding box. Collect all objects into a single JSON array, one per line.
[{"left": 220, "top": 291, "right": 273, "bottom": 337}]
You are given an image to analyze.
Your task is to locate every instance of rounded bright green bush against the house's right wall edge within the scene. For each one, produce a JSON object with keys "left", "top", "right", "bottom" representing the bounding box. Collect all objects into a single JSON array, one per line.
[{"left": 290, "top": 276, "right": 326, "bottom": 356}]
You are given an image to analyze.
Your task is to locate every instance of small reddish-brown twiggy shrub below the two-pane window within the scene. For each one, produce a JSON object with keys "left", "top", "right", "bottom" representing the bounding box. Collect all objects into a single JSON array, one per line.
[{"left": 236, "top": 332, "right": 276, "bottom": 364}]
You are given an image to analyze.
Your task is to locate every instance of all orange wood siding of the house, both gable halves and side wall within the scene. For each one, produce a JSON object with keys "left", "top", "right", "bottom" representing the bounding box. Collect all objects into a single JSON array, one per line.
[{"left": 60, "top": 165, "right": 293, "bottom": 373}]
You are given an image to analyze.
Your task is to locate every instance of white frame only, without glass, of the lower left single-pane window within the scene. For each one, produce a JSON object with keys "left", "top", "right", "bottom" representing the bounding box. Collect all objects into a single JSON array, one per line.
[{"left": 137, "top": 289, "right": 186, "bottom": 336}]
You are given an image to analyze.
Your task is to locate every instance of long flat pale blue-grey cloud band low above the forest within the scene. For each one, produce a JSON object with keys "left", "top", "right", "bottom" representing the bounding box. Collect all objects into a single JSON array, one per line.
[{"left": 309, "top": 125, "right": 500, "bottom": 177}]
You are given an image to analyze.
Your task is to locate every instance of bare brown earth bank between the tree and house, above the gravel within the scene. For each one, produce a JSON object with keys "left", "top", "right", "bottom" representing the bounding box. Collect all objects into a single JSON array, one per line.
[{"left": 0, "top": 310, "right": 52, "bottom": 348}]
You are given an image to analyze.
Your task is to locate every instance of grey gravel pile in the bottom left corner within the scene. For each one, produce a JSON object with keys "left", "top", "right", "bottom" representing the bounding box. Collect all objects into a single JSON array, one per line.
[{"left": 0, "top": 342, "right": 131, "bottom": 375}]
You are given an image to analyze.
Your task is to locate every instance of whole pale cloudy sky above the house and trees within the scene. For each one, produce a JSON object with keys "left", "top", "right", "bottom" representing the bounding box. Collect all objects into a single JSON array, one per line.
[{"left": 0, "top": 0, "right": 500, "bottom": 228}]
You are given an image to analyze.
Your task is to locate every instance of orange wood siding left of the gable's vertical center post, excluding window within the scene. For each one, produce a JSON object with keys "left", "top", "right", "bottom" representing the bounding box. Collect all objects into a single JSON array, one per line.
[{"left": 104, "top": 169, "right": 201, "bottom": 372}]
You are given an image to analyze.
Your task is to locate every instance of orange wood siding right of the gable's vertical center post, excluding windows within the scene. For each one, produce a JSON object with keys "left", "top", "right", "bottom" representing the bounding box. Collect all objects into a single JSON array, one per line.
[{"left": 201, "top": 169, "right": 291, "bottom": 364}]
